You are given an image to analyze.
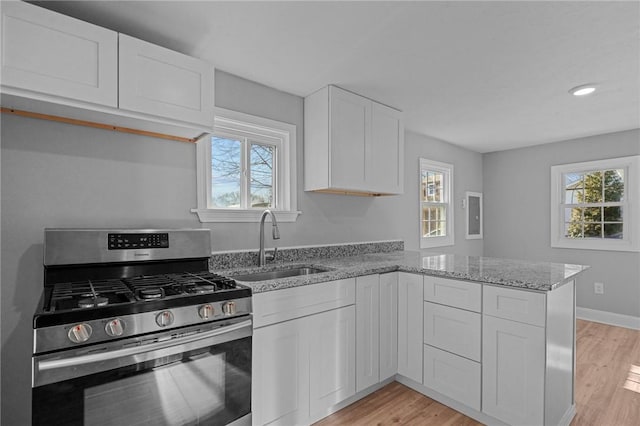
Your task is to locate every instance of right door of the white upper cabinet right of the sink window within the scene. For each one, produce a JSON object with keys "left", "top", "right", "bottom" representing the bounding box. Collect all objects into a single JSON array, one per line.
[{"left": 365, "top": 102, "right": 404, "bottom": 194}]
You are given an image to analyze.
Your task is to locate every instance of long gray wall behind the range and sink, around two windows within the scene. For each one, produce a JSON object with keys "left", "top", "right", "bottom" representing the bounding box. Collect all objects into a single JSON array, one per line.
[{"left": 0, "top": 72, "right": 482, "bottom": 425}]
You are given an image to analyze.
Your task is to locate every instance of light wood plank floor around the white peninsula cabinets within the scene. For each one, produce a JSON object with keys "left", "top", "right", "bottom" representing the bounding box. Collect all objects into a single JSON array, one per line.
[{"left": 315, "top": 320, "right": 640, "bottom": 426}]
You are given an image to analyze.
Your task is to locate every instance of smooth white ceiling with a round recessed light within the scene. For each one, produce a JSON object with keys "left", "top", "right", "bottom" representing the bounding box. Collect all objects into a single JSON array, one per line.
[{"left": 31, "top": 1, "right": 640, "bottom": 152}]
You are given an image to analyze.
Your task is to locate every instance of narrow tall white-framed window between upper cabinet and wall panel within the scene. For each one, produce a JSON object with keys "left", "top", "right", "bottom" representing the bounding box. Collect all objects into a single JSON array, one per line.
[{"left": 420, "top": 158, "right": 454, "bottom": 248}]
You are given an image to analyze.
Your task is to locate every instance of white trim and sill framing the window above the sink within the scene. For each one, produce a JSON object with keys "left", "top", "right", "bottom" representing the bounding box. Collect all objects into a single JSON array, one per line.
[{"left": 191, "top": 108, "right": 302, "bottom": 223}]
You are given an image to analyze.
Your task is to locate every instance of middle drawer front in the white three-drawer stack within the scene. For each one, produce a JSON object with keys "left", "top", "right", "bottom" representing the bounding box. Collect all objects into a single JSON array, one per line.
[{"left": 424, "top": 302, "right": 482, "bottom": 361}]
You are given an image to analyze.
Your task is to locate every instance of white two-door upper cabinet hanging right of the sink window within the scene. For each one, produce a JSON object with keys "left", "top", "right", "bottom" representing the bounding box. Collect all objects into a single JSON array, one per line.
[{"left": 304, "top": 86, "right": 404, "bottom": 195}]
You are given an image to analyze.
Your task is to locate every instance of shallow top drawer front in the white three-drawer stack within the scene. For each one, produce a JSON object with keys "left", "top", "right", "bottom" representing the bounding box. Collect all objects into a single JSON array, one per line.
[{"left": 424, "top": 276, "right": 482, "bottom": 312}]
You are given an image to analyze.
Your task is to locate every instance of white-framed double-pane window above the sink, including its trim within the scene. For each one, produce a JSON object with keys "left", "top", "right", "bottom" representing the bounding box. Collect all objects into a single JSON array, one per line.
[{"left": 192, "top": 108, "right": 300, "bottom": 222}]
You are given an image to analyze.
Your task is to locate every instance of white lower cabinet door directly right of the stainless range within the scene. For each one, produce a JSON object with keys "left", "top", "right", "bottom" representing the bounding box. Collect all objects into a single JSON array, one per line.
[{"left": 251, "top": 318, "right": 309, "bottom": 425}]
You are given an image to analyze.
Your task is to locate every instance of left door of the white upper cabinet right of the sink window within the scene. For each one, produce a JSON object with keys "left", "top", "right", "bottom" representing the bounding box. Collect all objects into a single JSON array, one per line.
[{"left": 329, "top": 86, "right": 371, "bottom": 190}]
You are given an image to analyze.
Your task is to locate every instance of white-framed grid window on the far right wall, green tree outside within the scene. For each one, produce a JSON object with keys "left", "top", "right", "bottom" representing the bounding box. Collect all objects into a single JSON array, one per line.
[{"left": 551, "top": 156, "right": 640, "bottom": 251}]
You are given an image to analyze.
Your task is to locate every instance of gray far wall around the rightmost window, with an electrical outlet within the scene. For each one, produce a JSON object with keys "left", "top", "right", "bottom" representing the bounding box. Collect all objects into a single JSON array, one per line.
[{"left": 483, "top": 130, "right": 640, "bottom": 317}]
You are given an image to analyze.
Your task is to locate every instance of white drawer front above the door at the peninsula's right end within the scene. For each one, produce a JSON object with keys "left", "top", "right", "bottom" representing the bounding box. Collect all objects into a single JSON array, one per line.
[{"left": 482, "top": 285, "right": 546, "bottom": 327}]
